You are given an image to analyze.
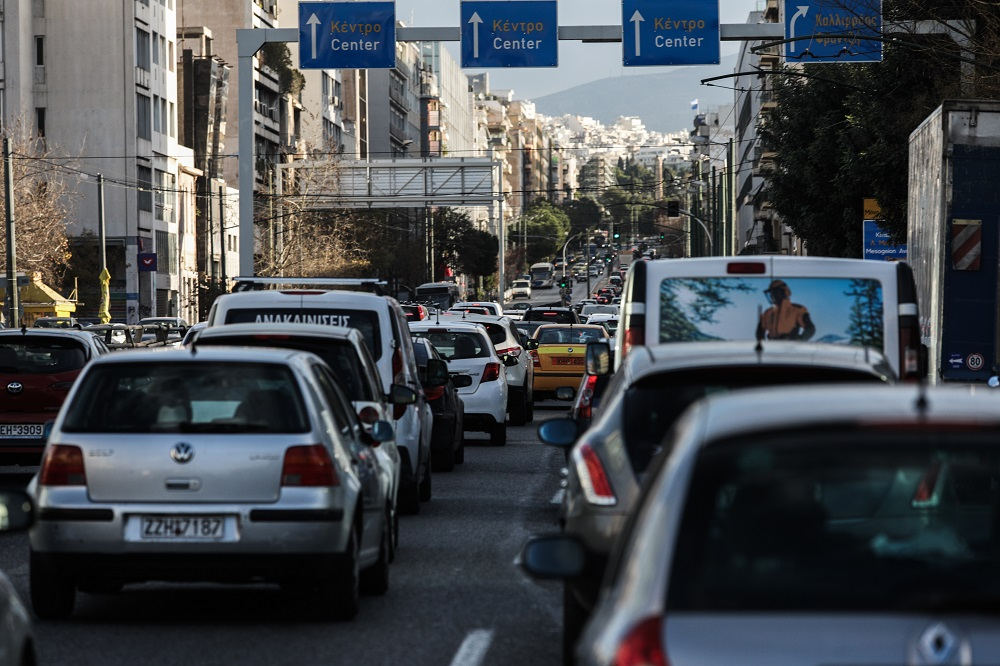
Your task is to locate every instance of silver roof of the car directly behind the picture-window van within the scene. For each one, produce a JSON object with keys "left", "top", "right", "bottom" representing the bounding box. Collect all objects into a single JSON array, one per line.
[{"left": 624, "top": 340, "right": 896, "bottom": 381}]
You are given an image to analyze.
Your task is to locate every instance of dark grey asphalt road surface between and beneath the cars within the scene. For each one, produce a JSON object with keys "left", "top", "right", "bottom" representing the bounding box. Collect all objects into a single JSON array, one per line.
[{"left": 0, "top": 402, "right": 565, "bottom": 666}]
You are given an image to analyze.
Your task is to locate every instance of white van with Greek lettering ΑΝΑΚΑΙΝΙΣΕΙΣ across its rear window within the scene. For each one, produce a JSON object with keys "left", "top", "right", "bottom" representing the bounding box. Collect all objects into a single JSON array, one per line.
[{"left": 206, "top": 278, "right": 434, "bottom": 514}]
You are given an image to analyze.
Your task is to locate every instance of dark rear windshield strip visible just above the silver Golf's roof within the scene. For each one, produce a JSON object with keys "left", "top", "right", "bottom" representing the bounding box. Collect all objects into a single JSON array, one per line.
[{"left": 198, "top": 333, "right": 375, "bottom": 401}]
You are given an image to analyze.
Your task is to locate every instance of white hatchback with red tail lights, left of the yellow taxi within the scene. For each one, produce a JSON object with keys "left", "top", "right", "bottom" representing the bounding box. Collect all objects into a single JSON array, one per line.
[{"left": 410, "top": 321, "right": 518, "bottom": 446}]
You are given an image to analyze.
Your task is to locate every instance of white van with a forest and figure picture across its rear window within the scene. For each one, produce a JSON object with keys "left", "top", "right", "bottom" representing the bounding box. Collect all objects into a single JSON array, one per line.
[{"left": 615, "top": 255, "right": 927, "bottom": 381}]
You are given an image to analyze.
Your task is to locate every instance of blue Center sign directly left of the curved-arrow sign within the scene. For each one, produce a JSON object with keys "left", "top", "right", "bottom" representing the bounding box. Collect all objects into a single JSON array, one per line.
[{"left": 622, "top": 0, "right": 721, "bottom": 67}]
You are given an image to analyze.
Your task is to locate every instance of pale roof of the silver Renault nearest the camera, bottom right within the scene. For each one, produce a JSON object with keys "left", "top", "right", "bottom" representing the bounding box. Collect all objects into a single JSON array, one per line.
[{"left": 692, "top": 384, "right": 1000, "bottom": 442}]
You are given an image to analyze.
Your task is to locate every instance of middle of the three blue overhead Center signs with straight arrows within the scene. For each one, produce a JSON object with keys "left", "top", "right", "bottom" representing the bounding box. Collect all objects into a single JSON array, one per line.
[{"left": 461, "top": 0, "right": 559, "bottom": 67}]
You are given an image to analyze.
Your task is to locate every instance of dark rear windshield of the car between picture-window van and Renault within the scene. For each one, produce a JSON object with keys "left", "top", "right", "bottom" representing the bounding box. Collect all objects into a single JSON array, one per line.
[{"left": 622, "top": 365, "right": 884, "bottom": 474}]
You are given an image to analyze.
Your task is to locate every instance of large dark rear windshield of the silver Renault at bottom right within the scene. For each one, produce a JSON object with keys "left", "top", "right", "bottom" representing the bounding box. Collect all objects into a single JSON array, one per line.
[{"left": 667, "top": 424, "right": 1000, "bottom": 615}]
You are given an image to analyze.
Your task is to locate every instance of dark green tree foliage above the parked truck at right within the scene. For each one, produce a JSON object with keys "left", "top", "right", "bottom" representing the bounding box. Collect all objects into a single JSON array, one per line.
[{"left": 760, "top": 0, "right": 1000, "bottom": 257}]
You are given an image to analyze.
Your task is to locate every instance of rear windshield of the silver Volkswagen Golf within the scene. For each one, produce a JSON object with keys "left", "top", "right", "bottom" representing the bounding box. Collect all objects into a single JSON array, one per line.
[{"left": 62, "top": 361, "right": 309, "bottom": 434}]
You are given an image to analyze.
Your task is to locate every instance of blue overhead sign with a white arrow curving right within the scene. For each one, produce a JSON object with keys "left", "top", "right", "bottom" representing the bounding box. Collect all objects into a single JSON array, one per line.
[{"left": 785, "top": 0, "right": 882, "bottom": 63}]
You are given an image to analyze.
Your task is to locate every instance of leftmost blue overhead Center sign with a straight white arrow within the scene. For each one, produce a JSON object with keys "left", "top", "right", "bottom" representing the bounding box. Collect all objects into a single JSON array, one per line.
[{"left": 299, "top": 2, "right": 396, "bottom": 69}]
